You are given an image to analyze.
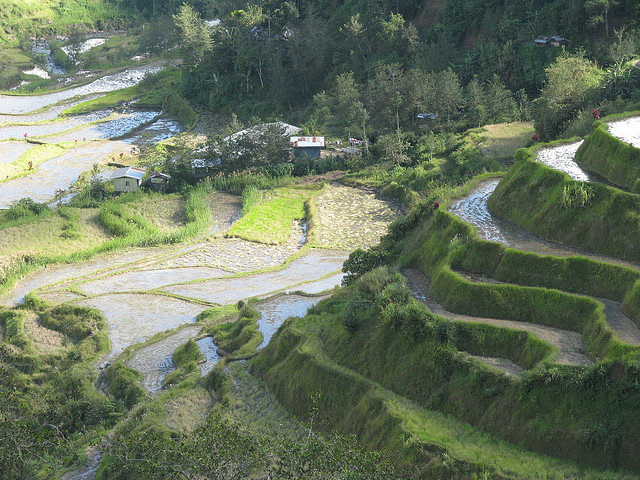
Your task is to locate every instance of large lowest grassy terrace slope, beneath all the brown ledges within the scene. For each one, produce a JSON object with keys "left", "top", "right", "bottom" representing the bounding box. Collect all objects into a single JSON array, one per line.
[{"left": 254, "top": 288, "right": 640, "bottom": 472}]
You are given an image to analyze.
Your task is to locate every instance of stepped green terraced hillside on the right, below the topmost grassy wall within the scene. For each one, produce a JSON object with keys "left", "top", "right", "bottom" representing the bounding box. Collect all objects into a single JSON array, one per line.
[{"left": 255, "top": 118, "right": 640, "bottom": 479}]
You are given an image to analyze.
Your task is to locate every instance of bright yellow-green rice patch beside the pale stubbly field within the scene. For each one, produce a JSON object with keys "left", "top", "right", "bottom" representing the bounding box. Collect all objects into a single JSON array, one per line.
[{"left": 227, "top": 188, "right": 315, "bottom": 245}]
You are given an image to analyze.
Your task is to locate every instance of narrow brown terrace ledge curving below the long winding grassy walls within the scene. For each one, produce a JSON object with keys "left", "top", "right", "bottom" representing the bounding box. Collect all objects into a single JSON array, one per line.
[{"left": 402, "top": 270, "right": 593, "bottom": 366}]
